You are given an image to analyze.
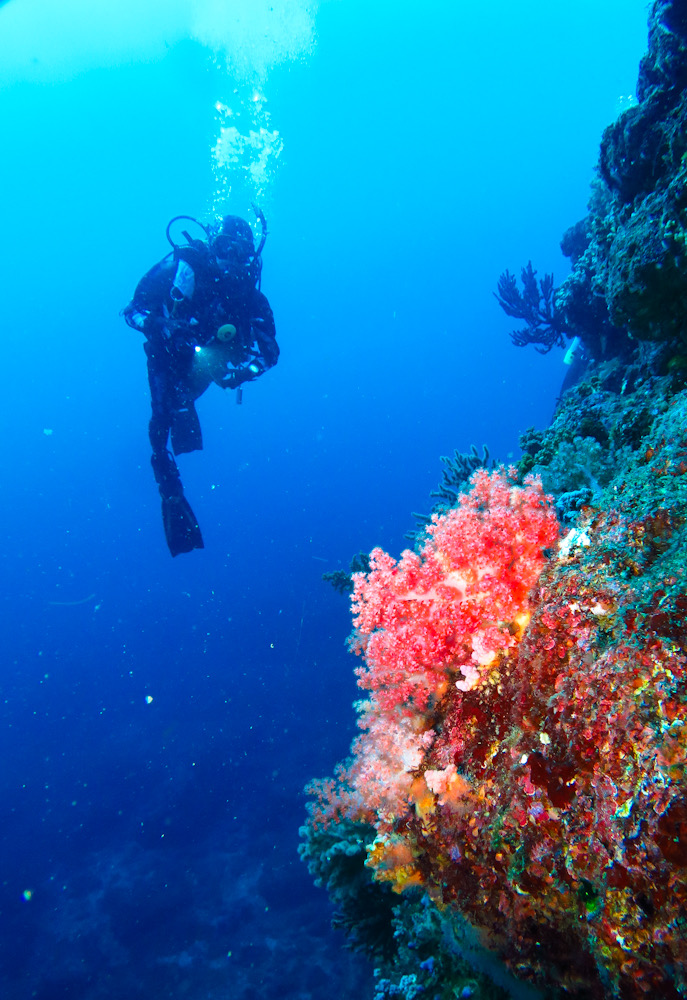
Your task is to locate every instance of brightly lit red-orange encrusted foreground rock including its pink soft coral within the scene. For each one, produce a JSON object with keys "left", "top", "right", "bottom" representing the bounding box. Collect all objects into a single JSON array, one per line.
[{"left": 310, "top": 456, "right": 687, "bottom": 997}]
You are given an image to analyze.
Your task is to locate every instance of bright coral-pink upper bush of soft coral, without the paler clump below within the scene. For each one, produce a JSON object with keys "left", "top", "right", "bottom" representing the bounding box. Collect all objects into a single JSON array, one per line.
[{"left": 353, "top": 469, "right": 558, "bottom": 713}]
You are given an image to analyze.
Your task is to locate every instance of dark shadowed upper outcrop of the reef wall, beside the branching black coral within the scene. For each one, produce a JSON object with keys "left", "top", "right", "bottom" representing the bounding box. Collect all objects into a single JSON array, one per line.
[{"left": 557, "top": 0, "right": 687, "bottom": 357}]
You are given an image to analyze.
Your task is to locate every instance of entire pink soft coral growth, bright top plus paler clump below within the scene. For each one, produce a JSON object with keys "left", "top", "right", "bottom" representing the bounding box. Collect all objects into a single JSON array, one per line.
[{"left": 313, "top": 470, "right": 558, "bottom": 828}]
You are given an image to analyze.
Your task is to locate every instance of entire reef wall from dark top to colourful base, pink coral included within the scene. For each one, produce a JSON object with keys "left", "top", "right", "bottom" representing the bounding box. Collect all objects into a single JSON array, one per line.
[{"left": 301, "top": 0, "right": 687, "bottom": 1000}]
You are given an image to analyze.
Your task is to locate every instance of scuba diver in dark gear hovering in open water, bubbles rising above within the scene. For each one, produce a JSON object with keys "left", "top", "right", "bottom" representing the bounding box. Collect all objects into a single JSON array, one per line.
[{"left": 122, "top": 206, "right": 279, "bottom": 556}]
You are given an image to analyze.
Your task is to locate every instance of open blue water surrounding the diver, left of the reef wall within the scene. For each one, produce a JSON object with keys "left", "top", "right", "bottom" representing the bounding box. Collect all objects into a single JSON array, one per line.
[{"left": 0, "top": 0, "right": 647, "bottom": 1000}]
